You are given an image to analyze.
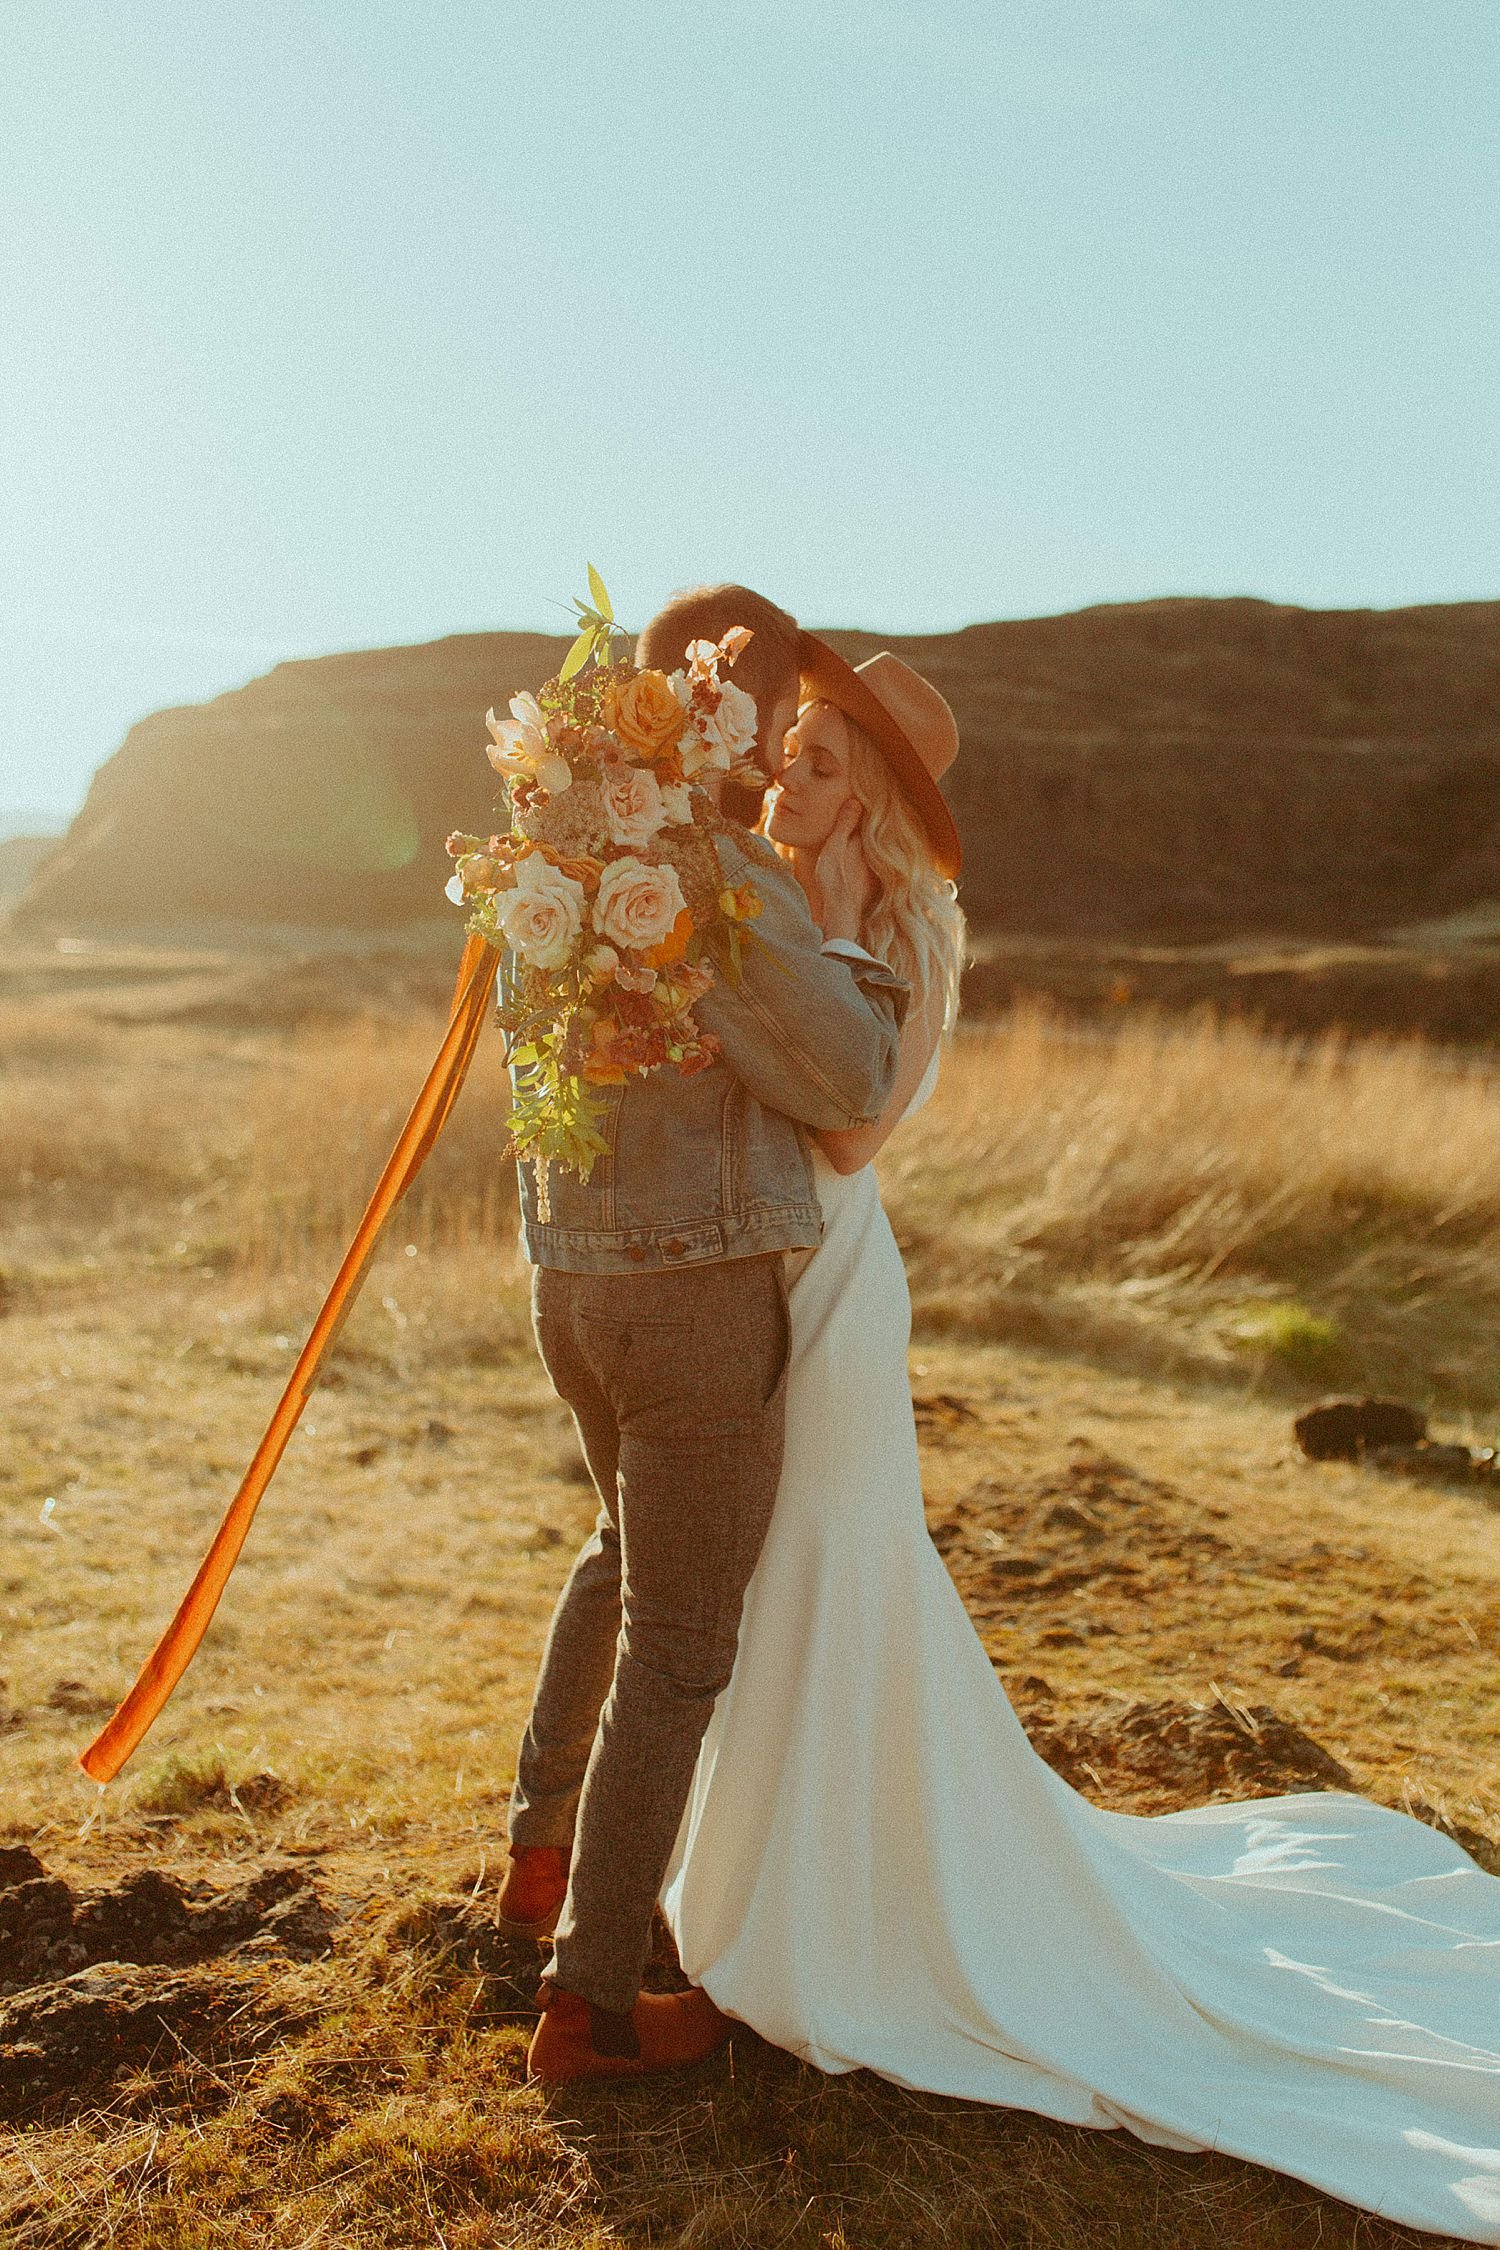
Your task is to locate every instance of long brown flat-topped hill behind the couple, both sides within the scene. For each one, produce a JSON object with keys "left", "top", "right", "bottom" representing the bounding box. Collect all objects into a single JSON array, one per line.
[{"left": 18, "top": 601, "right": 1500, "bottom": 938}]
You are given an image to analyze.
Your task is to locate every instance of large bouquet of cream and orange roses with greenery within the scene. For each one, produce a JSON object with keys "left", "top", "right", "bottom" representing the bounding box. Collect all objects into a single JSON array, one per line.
[{"left": 448, "top": 567, "right": 762, "bottom": 1220}]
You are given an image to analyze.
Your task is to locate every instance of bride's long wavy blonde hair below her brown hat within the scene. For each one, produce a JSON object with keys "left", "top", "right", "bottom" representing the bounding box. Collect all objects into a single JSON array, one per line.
[{"left": 778, "top": 704, "right": 967, "bottom": 1031}]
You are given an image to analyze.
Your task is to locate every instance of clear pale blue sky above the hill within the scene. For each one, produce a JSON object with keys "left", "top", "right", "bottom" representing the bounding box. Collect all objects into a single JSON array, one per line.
[{"left": 0, "top": 0, "right": 1500, "bottom": 819}]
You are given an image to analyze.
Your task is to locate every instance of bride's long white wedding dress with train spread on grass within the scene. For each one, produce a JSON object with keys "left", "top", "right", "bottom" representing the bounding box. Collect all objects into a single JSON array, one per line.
[{"left": 663, "top": 1073, "right": 1500, "bottom": 2243}]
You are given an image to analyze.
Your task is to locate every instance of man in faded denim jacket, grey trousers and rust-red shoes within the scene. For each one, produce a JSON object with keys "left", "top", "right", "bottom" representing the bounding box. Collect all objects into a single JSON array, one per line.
[{"left": 499, "top": 585, "right": 906, "bottom": 2084}]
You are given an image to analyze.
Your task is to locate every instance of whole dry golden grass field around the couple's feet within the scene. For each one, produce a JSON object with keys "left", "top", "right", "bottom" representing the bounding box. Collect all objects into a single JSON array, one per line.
[{"left": 0, "top": 972, "right": 1500, "bottom": 2250}]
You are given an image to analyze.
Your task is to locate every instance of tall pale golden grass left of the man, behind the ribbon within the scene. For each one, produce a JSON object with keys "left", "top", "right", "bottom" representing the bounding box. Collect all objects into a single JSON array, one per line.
[{"left": 0, "top": 1006, "right": 515, "bottom": 1276}]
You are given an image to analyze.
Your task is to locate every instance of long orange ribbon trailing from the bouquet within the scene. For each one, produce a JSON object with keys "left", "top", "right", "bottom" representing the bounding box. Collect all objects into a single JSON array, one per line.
[{"left": 79, "top": 938, "right": 499, "bottom": 1782}]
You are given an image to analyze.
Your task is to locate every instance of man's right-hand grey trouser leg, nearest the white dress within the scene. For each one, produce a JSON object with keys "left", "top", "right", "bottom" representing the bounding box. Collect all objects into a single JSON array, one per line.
[{"left": 555, "top": 1256, "right": 789, "bottom": 2014}]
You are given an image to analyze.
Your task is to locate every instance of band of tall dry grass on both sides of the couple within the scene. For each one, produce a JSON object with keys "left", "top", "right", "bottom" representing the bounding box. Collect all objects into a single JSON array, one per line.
[{"left": 0, "top": 1006, "right": 1500, "bottom": 1411}]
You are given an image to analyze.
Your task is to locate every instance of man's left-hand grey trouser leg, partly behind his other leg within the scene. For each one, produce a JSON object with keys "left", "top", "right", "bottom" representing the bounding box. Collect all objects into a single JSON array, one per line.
[{"left": 508, "top": 1271, "right": 621, "bottom": 1852}]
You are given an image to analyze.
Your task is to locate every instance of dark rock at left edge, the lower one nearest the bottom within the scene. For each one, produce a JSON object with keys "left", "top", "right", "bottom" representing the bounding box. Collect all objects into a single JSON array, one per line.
[{"left": 0, "top": 1962, "right": 261, "bottom": 2117}]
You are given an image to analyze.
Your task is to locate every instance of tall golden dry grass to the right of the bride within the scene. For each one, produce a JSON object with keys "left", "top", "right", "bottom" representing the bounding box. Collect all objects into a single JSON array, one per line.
[{"left": 886, "top": 1008, "right": 1500, "bottom": 1415}]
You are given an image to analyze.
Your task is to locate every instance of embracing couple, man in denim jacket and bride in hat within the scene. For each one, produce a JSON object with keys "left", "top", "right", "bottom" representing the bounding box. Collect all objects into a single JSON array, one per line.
[{"left": 499, "top": 585, "right": 1500, "bottom": 2243}]
